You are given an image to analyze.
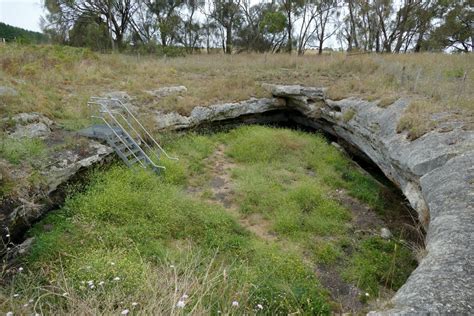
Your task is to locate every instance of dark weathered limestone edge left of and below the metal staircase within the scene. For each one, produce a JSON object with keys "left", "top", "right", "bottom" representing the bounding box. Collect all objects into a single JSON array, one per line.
[{"left": 0, "top": 135, "right": 112, "bottom": 240}]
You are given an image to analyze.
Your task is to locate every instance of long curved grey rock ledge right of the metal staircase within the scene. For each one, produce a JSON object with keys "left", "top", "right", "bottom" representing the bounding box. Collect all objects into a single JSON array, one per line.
[{"left": 156, "top": 85, "right": 474, "bottom": 314}]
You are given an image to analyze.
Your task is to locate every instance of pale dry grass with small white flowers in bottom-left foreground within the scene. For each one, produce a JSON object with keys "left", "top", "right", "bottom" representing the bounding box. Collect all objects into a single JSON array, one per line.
[{"left": 0, "top": 245, "right": 252, "bottom": 315}]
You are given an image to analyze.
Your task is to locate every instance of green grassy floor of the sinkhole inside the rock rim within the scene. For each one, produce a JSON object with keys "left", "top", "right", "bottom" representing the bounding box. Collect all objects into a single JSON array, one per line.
[{"left": 0, "top": 126, "right": 415, "bottom": 315}]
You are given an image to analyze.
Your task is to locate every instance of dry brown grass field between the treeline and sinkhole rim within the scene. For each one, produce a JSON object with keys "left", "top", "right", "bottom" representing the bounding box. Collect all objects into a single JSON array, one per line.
[{"left": 0, "top": 45, "right": 474, "bottom": 134}]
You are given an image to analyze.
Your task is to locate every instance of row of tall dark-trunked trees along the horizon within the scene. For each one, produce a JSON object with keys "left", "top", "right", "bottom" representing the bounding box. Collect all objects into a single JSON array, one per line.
[{"left": 44, "top": 0, "right": 474, "bottom": 54}]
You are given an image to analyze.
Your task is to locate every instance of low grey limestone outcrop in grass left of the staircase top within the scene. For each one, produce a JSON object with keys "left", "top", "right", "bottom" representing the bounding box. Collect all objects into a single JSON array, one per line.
[{"left": 2, "top": 113, "right": 53, "bottom": 138}]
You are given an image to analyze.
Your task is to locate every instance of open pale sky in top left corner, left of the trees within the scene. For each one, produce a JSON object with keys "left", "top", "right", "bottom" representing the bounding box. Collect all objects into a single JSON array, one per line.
[{"left": 0, "top": 0, "right": 44, "bottom": 31}]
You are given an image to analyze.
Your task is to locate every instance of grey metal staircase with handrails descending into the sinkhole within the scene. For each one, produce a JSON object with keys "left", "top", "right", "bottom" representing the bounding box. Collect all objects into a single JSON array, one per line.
[{"left": 81, "top": 97, "right": 178, "bottom": 173}]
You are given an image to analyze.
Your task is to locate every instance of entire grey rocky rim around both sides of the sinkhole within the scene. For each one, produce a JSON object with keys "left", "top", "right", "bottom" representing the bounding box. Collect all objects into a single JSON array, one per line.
[{"left": 0, "top": 85, "right": 474, "bottom": 314}]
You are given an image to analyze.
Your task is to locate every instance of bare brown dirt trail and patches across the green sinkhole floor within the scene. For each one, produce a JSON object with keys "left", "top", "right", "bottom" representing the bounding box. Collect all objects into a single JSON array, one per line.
[{"left": 188, "top": 144, "right": 396, "bottom": 314}]
